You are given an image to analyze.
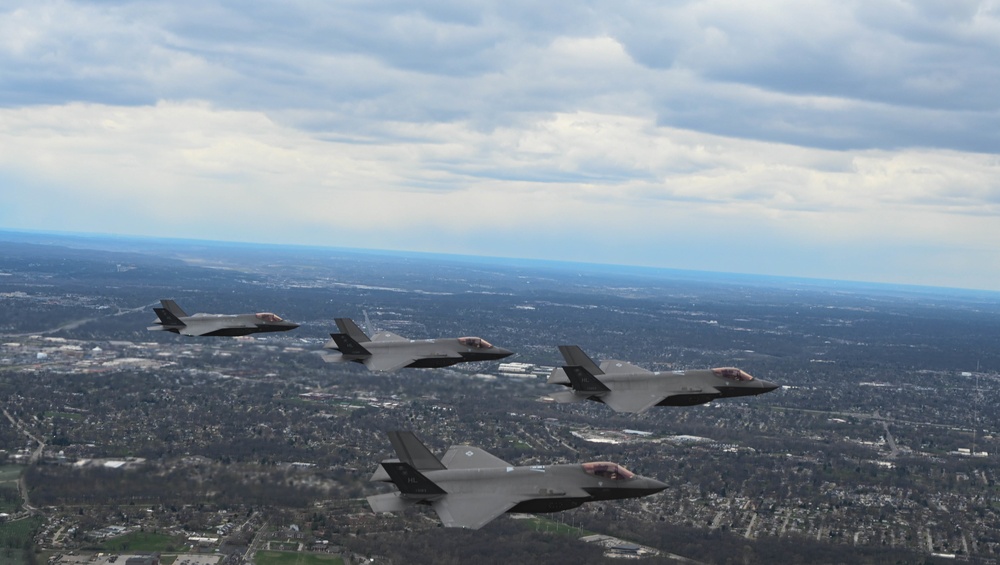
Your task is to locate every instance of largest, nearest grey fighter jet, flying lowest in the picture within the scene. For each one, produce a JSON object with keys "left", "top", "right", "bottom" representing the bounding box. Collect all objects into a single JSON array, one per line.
[{"left": 368, "top": 431, "right": 667, "bottom": 530}]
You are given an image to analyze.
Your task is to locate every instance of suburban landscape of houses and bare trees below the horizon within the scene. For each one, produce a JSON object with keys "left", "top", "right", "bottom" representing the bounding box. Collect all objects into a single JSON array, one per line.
[{"left": 0, "top": 233, "right": 1000, "bottom": 565}]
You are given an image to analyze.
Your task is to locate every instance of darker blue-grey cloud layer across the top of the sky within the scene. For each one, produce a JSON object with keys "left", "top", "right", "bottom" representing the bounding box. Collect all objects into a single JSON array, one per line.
[{"left": 7, "top": 0, "right": 1000, "bottom": 152}]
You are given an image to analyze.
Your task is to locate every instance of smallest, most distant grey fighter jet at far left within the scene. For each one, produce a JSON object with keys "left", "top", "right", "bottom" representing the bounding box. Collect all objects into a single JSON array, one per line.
[{"left": 146, "top": 300, "right": 299, "bottom": 336}]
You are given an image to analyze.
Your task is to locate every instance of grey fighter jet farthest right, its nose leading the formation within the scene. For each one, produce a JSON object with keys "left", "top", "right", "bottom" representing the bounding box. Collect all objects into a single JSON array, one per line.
[{"left": 548, "top": 345, "right": 781, "bottom": 414}]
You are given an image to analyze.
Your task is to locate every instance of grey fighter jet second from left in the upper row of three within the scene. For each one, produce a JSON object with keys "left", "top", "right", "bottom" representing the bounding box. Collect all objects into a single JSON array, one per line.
[{"left": 323, "top": 318, "right": 514, "bottom": 371}]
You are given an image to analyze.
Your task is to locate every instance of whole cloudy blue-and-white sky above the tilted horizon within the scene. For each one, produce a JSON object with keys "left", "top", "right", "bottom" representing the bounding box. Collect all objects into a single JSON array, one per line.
[{"left": 0, "top": 0, "right": 1000, "bottom": 290}]
